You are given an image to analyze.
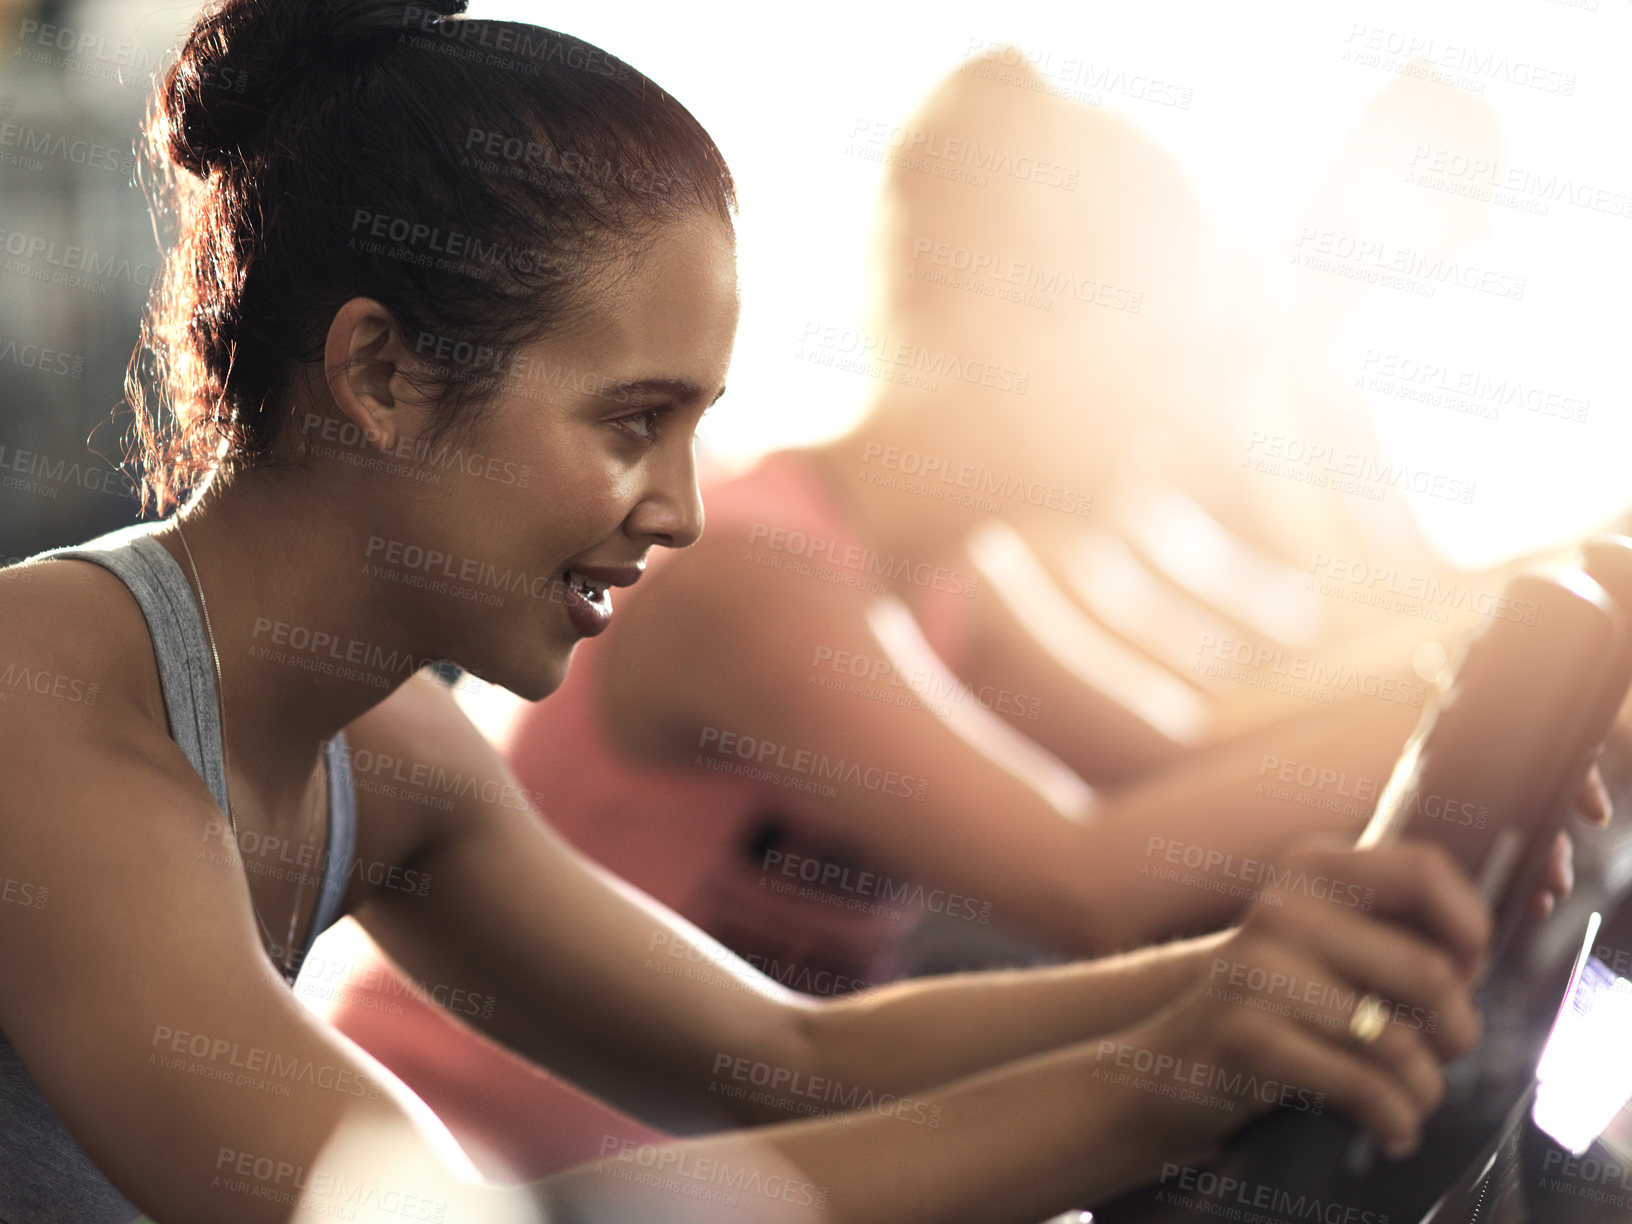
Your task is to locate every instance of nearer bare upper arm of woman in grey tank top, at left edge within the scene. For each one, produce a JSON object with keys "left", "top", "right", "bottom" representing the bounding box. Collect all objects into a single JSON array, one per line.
[{"left": 0, "top": 685, "right": 496, "bottom": 1224}]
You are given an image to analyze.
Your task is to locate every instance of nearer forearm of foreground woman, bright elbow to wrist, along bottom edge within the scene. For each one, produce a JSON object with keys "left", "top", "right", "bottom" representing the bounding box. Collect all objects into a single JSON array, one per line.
[{"left": 286, "top": 1043, "right": 1148, "bottom": 1224}]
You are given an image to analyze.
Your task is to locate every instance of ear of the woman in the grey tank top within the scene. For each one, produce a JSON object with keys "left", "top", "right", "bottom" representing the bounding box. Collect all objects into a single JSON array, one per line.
[{"left": 323, "top": 297, "right": 428, "bottom": 450}]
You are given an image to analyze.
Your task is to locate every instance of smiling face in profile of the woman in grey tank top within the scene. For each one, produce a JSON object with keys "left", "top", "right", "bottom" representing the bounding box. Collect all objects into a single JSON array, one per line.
[{"left": 401, "top": 214, "right": 738, "bottom": 700}]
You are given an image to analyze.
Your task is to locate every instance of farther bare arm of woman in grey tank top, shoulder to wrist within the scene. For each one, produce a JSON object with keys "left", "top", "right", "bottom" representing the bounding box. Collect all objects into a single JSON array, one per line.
[{"left": 337, "top": 677, "right": 1217, "bottom": 1131}]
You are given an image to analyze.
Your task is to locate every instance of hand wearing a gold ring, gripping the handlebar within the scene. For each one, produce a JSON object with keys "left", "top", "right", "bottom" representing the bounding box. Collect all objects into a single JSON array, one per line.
[{"left": 1097, "top": 842, "right": 1490, "bottom": 1159}]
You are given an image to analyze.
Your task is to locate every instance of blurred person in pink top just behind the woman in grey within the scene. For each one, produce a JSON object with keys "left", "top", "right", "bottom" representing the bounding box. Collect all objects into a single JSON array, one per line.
[{"left": 328, "top": 52, "right": 1596, "bottom": 1175}]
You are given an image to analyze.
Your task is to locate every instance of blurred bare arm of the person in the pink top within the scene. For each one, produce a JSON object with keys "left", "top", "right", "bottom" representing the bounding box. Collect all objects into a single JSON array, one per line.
[{"left": 590, "top": 539, "right": 1417, "bottom": 953}]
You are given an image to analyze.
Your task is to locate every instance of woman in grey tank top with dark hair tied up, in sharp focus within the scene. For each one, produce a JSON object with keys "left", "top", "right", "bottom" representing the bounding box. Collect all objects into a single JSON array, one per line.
[{"left": 0, "top": 0, "right": 1527, "bottom": 1224}]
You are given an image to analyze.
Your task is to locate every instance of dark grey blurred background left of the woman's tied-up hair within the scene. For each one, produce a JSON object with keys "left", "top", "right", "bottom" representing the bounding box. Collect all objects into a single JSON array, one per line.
[{"left": 0, "top": 0, "right": 197, "bottom": 565}]
